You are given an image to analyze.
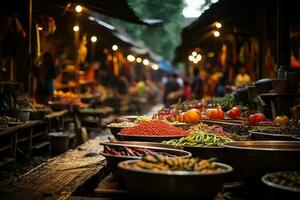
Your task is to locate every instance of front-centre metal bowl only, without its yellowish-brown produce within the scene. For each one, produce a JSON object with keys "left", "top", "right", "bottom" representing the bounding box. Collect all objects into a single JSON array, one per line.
[{"left": 118, "top": 160, "right": 233, "bottom": 199}]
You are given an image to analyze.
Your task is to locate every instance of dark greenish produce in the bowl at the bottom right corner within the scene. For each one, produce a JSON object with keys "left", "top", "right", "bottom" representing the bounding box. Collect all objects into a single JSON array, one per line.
[{"left": 265, "top": 171, "right": 300, "bottom": 190}]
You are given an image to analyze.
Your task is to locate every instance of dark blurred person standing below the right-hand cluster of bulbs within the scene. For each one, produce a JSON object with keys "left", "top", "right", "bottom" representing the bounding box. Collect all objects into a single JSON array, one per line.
[{"left": 191, "top": 68, "right": 204, "bottom": 100}]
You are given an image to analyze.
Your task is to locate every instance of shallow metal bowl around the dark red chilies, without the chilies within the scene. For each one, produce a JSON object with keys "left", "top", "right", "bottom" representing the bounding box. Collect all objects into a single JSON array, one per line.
[{"left": 100, "top": 142, "right": 192, "bottom": 180}]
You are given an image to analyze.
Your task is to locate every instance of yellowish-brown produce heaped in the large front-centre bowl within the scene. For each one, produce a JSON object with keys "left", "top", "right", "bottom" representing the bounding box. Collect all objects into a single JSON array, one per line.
[{"left": 122, "top": 155, "right": 224, "bottom": 173}]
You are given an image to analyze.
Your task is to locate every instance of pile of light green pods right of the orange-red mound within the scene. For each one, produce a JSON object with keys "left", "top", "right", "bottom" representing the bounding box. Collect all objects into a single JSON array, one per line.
[{"left": 163, "top": 131, "right": 233, "bottom": 147}]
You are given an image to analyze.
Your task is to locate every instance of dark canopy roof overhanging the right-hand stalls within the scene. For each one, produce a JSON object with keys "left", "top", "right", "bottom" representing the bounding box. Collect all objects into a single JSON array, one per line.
[{"left": 173, "top": 0, "right": 300, "bottom": 63}]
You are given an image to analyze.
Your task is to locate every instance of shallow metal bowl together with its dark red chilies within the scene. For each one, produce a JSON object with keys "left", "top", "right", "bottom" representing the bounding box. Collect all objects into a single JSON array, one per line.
[{"left": 100, "top": 142, "right": 192, "bottom": 180}]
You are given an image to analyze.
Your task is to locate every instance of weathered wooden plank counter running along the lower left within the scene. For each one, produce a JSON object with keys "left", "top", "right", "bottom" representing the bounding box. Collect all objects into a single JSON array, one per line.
[{"left": 0, "top": 138, "right": 104, "bottom": 200}]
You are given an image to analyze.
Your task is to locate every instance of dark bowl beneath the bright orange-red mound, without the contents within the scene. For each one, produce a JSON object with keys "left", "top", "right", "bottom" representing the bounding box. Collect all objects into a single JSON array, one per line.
[{"left": 119, "top": 134, "right": 185, "bottom": 142}]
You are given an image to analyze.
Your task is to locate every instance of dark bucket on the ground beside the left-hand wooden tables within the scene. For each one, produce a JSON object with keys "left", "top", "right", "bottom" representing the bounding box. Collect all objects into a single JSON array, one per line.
[{"left": 49, "top": 132, "right": 69, "bottom": 156}]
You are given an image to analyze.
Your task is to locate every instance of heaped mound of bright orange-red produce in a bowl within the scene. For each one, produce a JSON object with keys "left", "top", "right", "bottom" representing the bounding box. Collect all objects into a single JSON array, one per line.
[{"left": 121, "top": 120, "right": 188, "bottom": 136}]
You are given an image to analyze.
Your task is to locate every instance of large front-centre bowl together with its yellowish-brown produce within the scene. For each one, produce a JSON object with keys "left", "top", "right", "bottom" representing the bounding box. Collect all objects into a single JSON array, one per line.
[{"left": 118, "top": 156, "right": 233, "bottom": 199}]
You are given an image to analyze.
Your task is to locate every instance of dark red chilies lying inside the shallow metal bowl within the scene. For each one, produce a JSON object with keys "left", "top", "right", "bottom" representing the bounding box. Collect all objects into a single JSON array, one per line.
[{"left": 104, "top": 145, "right": 175, "bottom": 157}]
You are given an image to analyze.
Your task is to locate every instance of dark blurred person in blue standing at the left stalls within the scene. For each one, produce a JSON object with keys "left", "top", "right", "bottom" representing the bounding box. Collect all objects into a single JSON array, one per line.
[{"left": 33, "top": 52, "right": 57, "bottom": 105}]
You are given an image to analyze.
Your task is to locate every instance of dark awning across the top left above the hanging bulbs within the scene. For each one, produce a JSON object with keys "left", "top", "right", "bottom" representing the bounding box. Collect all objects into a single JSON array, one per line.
[{"left": 0, "top": 0, "right": 163, "bottom": 25}]
